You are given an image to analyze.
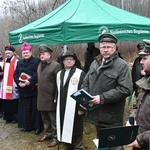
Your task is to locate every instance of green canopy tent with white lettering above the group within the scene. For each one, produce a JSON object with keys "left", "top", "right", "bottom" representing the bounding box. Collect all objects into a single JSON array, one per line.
[{"left": 9, "top": 0, "right": 150, "bottom": 46}]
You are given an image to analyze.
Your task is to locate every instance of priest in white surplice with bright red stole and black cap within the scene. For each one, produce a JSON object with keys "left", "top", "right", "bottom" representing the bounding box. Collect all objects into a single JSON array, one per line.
[{"left": 0, "top": 45, "right": 19, "bottom": 123}]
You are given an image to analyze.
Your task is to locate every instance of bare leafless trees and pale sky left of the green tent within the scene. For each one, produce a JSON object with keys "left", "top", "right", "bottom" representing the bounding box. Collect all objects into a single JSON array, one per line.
[{"left": 0, "top": 0, "right": 65, "bottom": 47}]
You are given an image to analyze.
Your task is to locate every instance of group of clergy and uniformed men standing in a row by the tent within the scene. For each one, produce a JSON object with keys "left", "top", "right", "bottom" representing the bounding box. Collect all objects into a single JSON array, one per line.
[{"left": 0, "top": 33, "right": 150, "bottom": 150}]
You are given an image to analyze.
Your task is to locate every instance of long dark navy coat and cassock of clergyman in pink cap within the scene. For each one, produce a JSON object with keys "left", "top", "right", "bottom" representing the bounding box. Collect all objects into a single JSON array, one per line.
[{"left": 14, "top": 56, "right": 42, "bottom": 130}]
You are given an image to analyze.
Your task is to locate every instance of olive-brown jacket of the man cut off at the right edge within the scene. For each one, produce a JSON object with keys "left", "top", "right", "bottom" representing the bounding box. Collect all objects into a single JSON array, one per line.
[{"left": 135, "top": 76, "right": 150, "bottom": 150}]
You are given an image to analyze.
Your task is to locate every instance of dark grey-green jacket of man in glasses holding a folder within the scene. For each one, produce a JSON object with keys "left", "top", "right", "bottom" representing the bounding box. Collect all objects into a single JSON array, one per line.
[{"left": 82, "top": 52, "right": 132, "bottom": 127}]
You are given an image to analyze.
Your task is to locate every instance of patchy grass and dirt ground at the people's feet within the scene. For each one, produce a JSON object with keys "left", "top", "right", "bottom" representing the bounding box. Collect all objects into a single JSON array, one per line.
[{"left": 0, "top": 99, "right": 134, "bottom": 150}]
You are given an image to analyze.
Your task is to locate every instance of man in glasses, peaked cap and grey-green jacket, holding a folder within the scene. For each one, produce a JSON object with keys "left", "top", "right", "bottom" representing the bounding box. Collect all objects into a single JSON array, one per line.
[{"left": 82, "top": 33, "right": 132, "bottom": 150}]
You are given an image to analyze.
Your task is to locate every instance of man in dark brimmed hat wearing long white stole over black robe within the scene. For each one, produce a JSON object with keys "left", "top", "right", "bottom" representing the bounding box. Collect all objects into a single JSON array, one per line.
[{"left": 56, "top": 51, "right": 85, "bottom": 150}]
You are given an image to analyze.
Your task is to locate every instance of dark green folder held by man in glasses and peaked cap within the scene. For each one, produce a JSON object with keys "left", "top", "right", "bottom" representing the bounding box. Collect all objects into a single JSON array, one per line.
[{"left": 71, "top": 89, "right": 99, "bottom": 111}]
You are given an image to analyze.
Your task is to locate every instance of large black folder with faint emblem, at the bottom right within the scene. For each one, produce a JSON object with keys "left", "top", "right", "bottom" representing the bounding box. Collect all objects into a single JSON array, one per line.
[{"left": 98, "top": 125, "right": 139, "bottom": 148}]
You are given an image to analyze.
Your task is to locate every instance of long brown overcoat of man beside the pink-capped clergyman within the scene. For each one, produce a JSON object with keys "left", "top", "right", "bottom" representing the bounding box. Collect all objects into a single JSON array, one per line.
[{"left": 37, "top": 60, "right": 61, "bottom": 111}]
